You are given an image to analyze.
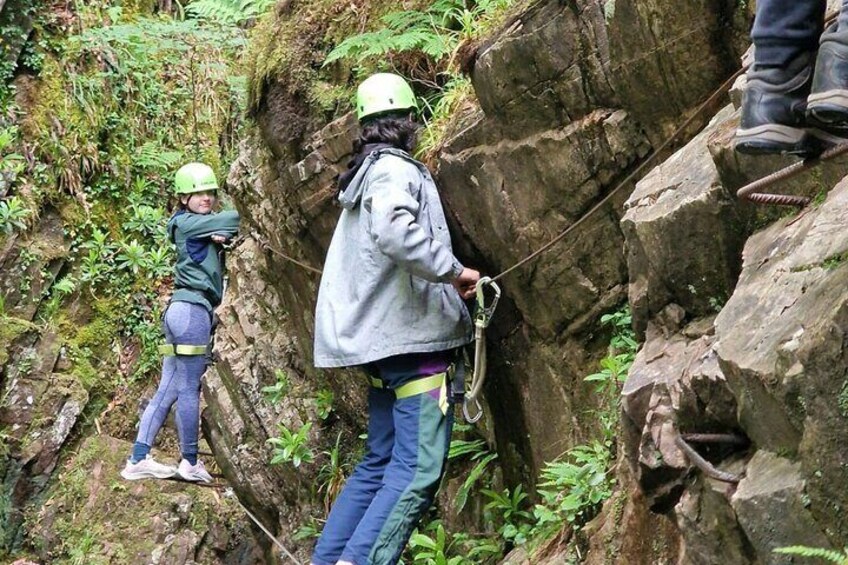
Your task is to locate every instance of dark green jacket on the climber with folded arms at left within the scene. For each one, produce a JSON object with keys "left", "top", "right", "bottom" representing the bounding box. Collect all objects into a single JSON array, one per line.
[{"left": 168, "top": 210, "right": 239, "bottom": 312}]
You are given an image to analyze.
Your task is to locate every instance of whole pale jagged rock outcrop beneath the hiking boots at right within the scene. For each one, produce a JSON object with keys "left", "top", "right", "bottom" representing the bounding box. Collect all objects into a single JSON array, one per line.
[{"left": 623, "top": 51, "right": 848, "bottom": 563}]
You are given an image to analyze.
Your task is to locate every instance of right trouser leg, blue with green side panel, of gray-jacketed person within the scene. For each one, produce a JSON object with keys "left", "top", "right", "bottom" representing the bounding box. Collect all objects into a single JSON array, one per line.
[{"left": 341, "top": 374, "right": 453, "bottom": 565}]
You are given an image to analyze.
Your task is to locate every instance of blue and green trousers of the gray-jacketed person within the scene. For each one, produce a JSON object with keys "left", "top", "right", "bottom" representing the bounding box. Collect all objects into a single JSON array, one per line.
[{"left": 312, "top": 356, "right": 453, "bottom": 565}]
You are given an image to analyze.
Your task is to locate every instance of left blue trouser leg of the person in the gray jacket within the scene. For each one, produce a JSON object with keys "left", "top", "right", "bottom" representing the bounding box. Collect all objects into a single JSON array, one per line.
[{"left": 312, "top": 388, "right": 395, "bottom": 565}]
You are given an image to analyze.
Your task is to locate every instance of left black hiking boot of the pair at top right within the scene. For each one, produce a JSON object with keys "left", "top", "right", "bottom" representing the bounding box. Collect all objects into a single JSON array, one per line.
[{"left": 734, "top": 53, "right": 813, "bottom": 155}]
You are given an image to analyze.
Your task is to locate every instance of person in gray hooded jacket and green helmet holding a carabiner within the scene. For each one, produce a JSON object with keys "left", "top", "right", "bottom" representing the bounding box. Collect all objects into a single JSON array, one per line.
[{"left": 312, "top": 73, "right": 480, "bottom": 565}]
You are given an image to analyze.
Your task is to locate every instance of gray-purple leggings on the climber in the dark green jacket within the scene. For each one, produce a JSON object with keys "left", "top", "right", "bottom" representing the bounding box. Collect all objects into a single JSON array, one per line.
[{"left": 136, "top": 302, "right": 212, "bottom": 457}]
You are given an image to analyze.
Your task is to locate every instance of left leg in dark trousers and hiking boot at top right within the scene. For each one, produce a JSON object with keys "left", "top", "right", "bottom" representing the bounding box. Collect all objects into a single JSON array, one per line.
[{"left": 735, "top": 0, "right": 826, "bottom": 154}]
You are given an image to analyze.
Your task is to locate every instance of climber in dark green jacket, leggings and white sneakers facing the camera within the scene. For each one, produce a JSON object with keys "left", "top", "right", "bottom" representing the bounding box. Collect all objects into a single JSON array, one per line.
[{"left": 121, "top": 163, "right": 239, "bottom": 482}]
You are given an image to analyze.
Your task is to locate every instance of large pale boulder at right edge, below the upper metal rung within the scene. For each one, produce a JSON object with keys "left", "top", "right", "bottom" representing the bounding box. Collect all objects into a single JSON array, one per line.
[{"left": 716, "top": 177, "right": 848, "bottom": 546}]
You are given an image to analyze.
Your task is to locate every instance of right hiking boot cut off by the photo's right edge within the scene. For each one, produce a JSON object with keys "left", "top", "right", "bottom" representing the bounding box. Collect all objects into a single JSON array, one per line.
[{"left": 807, "top": 31, "right": 848, "bottom": 136}]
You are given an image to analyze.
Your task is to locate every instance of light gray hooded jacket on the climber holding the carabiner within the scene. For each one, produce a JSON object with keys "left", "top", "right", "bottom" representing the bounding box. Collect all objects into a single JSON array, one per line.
[{"left": 315, "top": 149, "right": 472, "bottom": 367}]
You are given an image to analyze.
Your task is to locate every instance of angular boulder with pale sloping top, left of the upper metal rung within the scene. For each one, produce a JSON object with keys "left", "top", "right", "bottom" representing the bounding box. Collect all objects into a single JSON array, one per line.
[{"left": 621, "top": 107, "right": 745, "bottom": 331}]
